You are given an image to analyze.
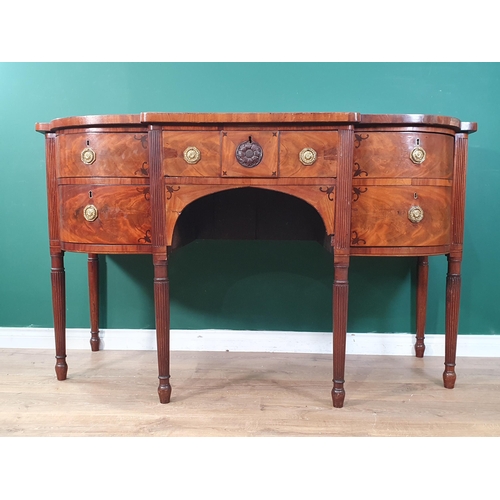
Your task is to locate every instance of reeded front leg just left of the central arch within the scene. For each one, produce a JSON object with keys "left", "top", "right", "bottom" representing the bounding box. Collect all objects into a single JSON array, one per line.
[{"left": 153, "top": 256, "right": 172, "bottom": 403}]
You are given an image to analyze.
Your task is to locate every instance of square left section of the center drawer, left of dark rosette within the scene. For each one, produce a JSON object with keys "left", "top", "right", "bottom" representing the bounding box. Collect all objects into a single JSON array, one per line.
[{"left": 163, "top": 131, "right": 220, "bottom": 177}]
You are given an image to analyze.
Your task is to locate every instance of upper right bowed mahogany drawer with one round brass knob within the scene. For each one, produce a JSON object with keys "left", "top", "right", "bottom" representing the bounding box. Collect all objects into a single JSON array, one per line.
[{"left": 354, "top": 131, "right": 454, "bottom": 179}]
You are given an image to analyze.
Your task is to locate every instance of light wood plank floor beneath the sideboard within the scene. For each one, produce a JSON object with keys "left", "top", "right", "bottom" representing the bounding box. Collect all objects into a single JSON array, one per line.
[{"left": 0, "top": 349, "right": 500, "bottom": 437}]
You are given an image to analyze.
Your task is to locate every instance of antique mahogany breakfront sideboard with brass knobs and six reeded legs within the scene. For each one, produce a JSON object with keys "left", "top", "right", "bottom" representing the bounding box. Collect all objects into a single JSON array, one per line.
[{"left": 36, "top": 112, "right": 477, "bottom": 408}]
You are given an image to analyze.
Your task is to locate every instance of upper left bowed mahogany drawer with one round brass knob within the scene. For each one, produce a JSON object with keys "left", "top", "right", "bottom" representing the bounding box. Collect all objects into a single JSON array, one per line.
[{"left": 57, "top": 132, "right": 149, "bottom": 177}]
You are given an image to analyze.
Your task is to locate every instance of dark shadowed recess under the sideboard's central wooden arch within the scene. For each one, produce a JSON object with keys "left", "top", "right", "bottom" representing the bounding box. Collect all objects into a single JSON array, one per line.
[{"left": 172, "top": 187, "right": 331, "bottom": 250}]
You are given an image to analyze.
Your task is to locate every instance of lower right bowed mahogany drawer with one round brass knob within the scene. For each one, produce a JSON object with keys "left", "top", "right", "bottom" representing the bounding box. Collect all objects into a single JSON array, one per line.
[{"left": 351, "top": 186, "right": 451, "bottom": 247}]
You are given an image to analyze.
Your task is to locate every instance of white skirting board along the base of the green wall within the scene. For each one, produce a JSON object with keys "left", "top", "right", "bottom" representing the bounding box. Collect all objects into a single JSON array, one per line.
[{"left": 0, "top": 327, "right": 500, "bottom": 357}]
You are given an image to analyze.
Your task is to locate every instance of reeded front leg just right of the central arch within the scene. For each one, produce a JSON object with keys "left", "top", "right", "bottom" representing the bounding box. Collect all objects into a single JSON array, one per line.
[{"left": 332, "top": 256, "right": 349, "bottom": 408}]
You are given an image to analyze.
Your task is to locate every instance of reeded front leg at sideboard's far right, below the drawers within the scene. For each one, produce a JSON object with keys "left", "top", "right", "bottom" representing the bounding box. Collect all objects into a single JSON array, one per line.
[{"left": 443, "top": 254, "right": 462, "bottom": 389}]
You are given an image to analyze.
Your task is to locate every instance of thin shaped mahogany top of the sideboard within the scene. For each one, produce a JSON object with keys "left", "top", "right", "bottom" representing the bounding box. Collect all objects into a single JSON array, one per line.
[{"left": 35, "top": 112, "right": 477, "bottom": 133}]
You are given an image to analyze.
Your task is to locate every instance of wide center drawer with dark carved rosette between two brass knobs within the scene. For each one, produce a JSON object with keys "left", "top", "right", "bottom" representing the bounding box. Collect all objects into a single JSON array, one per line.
[{"left": 162, "top": 130, "right": 339, "bottom": 178}]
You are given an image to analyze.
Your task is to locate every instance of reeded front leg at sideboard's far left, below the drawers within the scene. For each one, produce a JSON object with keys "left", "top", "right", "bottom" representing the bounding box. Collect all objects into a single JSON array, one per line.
[{"left": 50, "top": 251, "right": 68, "bottom": 380}]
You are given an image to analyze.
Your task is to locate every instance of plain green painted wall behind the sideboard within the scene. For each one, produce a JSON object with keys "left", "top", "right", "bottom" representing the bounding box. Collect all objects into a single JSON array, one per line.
[{"left": 0, "top": 63, "right": 500, "bottom": 334}]
